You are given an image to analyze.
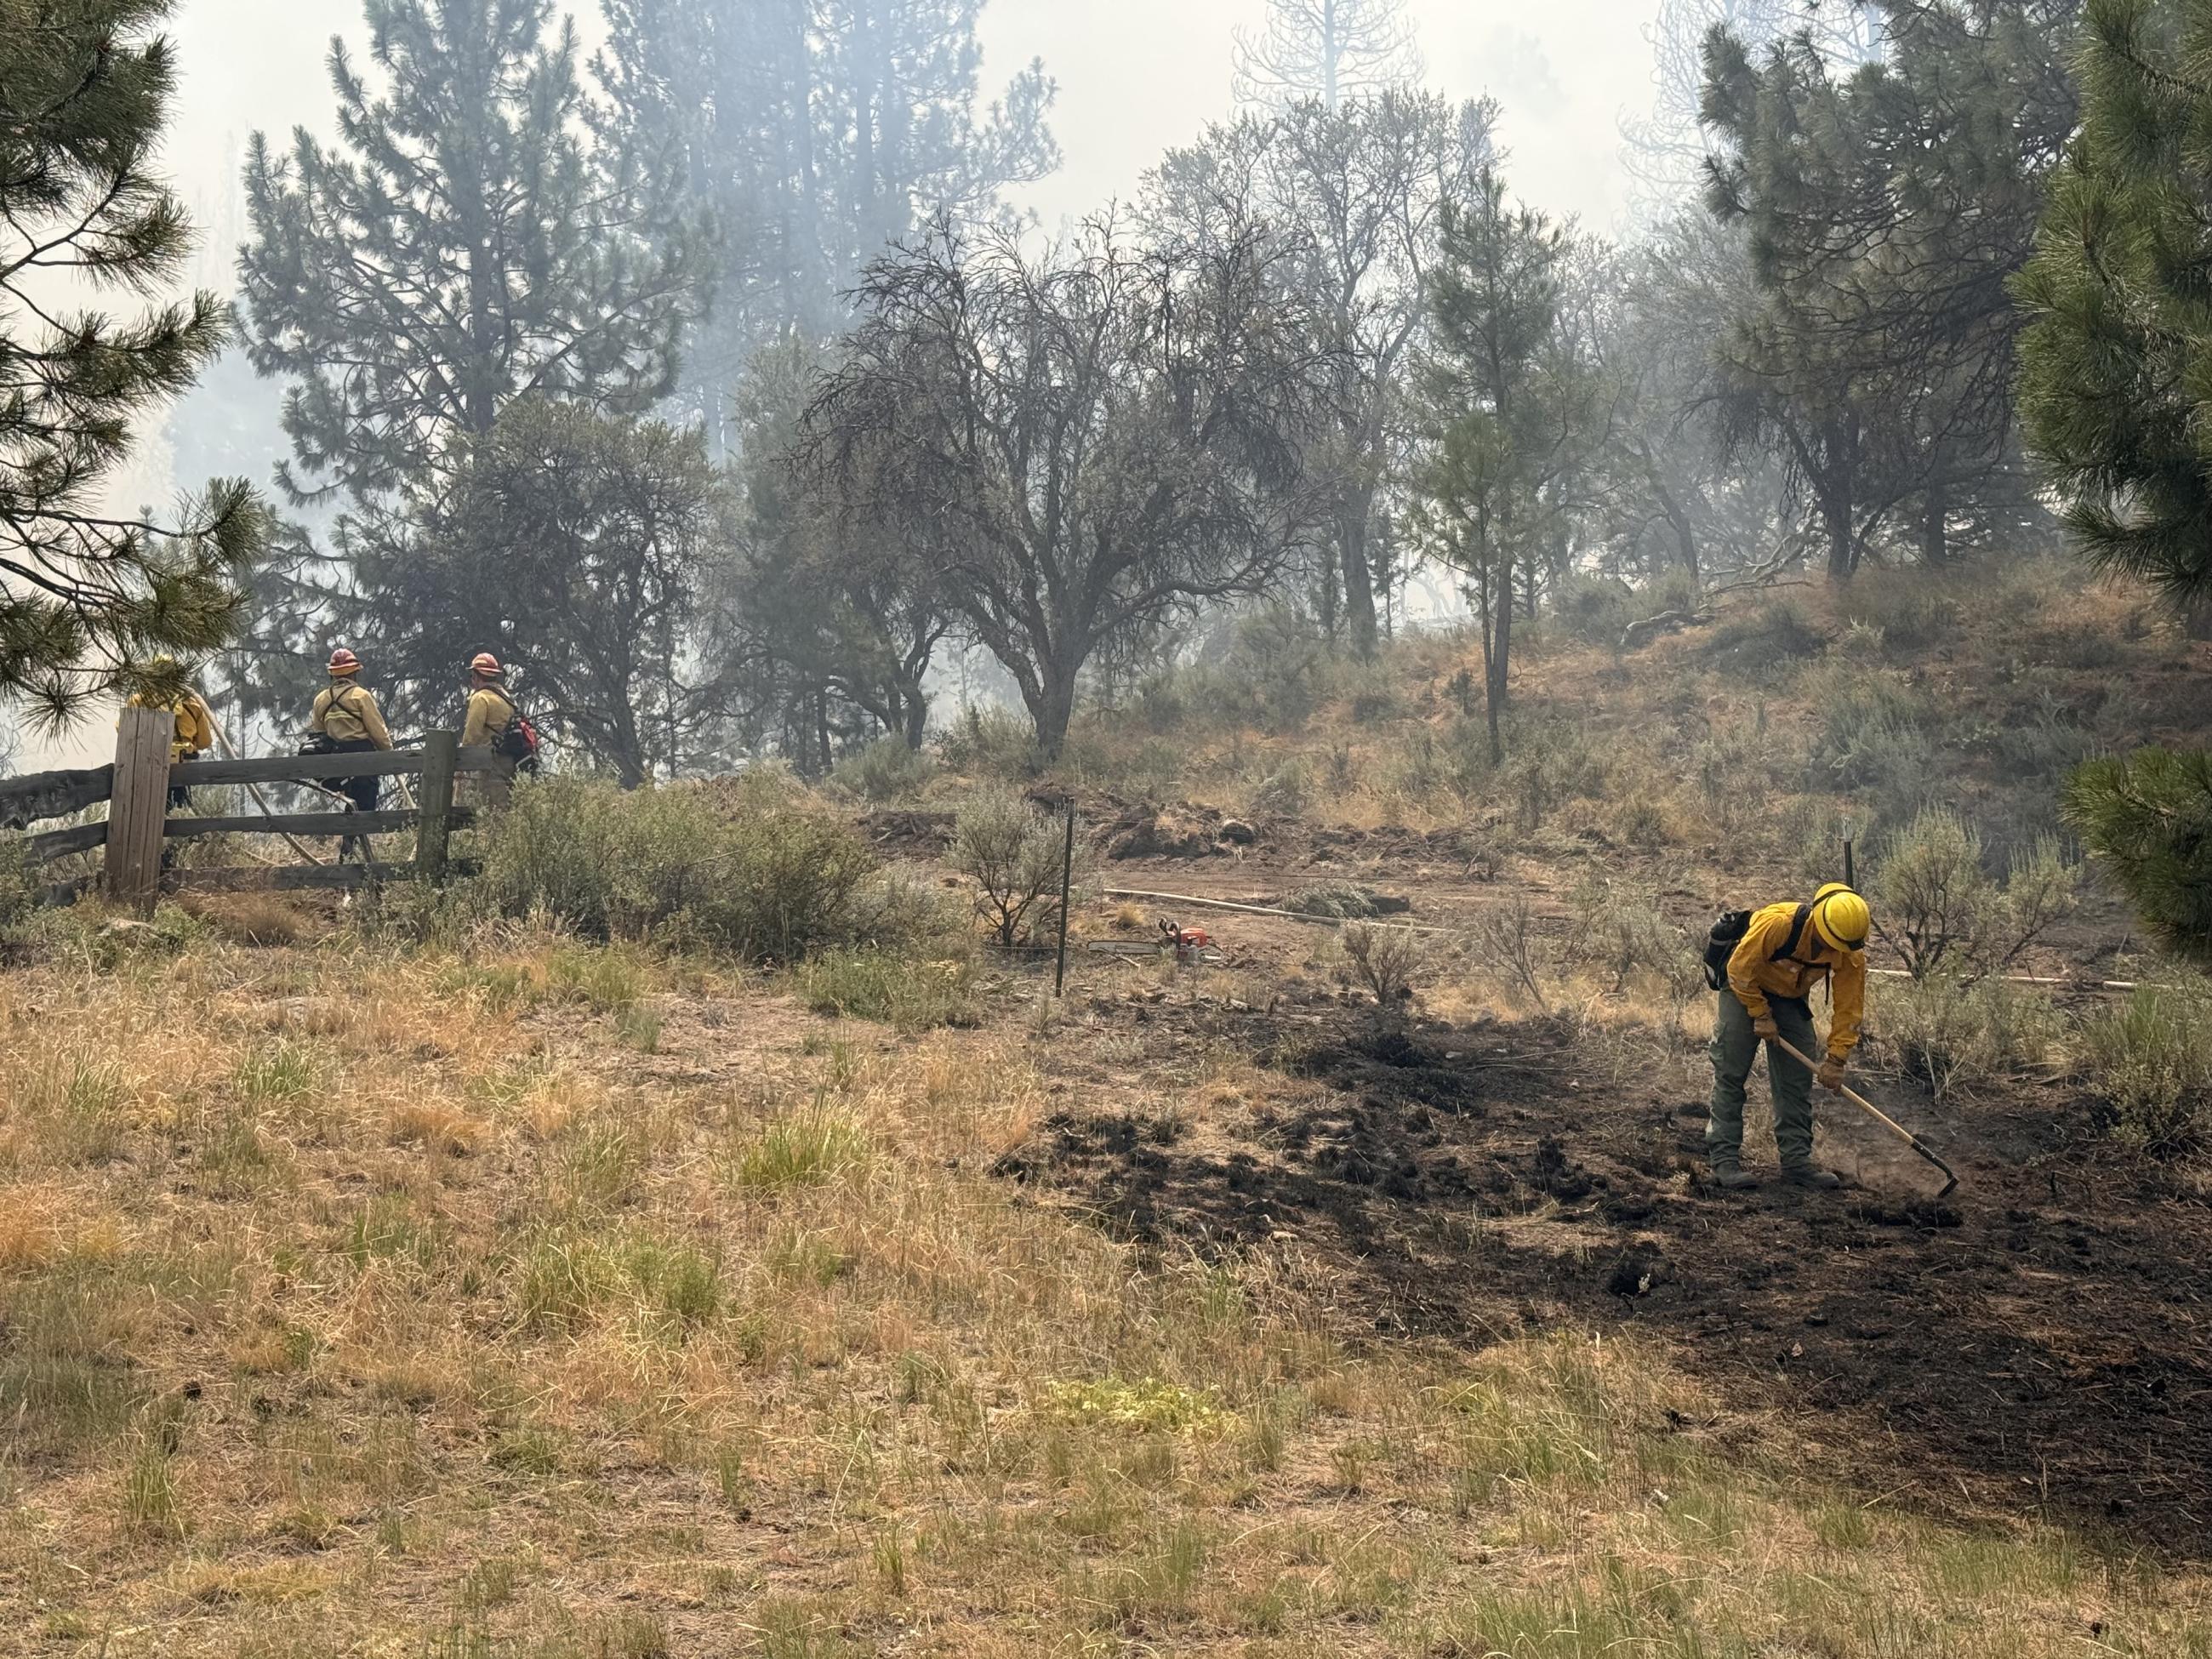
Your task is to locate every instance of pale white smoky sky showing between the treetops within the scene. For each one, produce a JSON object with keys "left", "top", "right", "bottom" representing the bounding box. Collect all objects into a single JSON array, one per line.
[{"left": 4, "top": 0, "right": 1659, "bottom": 763}]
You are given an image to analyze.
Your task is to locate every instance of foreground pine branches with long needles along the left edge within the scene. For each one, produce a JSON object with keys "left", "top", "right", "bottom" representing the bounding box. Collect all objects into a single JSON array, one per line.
[{"left": 0, "top": 0, "right": 268, "bottom": 726}]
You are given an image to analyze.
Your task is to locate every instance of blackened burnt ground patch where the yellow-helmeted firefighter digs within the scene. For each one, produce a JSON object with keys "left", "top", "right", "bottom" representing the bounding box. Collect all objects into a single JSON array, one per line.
[{"left": 1002, "top": 991, "right": 2212, "bottom": 1555}]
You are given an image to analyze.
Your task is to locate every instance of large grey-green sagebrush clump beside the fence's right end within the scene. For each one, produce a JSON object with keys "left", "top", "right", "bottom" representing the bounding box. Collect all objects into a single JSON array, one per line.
[{"left": 476, "top": 767, "right": 881, "bottom": 960}]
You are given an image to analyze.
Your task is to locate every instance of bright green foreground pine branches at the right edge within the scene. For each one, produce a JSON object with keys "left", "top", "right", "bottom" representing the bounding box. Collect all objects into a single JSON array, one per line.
[{"left": 2015, "top": 0, "right": 2212, "bottom": 962}]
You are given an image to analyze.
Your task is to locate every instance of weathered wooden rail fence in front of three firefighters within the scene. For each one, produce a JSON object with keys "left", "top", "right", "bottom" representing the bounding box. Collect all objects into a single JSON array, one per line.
[{"left": 0, "top": 708, "right": 513, "bottom": 924}]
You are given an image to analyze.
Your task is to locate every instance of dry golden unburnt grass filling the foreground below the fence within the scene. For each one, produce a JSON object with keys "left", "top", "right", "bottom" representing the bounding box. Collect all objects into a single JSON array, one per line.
[{"left": 0, "top": 940, "right": 2212, "bottom": 1659}]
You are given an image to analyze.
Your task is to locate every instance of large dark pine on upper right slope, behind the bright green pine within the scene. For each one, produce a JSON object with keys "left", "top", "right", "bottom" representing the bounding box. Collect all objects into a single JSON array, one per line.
[{"left": 1706, "top": 0, "right": 2079, "bottom": 579}]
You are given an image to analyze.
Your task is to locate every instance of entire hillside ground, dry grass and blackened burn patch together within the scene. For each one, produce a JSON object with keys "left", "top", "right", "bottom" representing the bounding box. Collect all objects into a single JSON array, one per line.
[{"left": 0, "top": 578, "right": 2212, "bottom": 1659}]
